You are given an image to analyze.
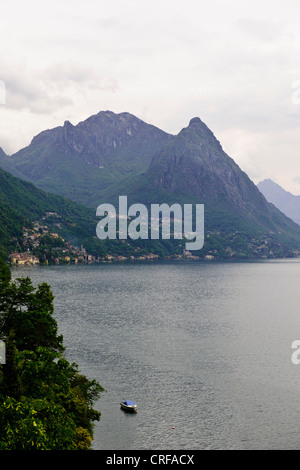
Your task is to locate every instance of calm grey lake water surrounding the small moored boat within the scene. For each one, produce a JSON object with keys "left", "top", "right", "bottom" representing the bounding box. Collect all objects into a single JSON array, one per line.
[{"left": 12, "top": 260, "right": 300, "bottom": 450}]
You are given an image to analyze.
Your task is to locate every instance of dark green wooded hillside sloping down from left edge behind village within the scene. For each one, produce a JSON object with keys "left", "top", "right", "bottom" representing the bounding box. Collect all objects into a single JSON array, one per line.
[{"left": 0, "top": 168, "right": 182, "bottom": 260}]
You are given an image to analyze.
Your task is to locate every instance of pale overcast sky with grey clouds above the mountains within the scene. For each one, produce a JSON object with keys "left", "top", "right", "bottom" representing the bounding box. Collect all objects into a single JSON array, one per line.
[{"left": 0, "top": 0, "right": 300, "bottom": 194}]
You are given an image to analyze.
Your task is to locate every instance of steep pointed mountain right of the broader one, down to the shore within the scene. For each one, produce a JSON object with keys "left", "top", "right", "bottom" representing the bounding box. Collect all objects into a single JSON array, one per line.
[{"left": 128, "top": 117, "right": 300, "bottom": 258}]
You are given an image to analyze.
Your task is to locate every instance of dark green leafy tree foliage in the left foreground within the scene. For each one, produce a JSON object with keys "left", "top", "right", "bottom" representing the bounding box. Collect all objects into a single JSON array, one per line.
[{"left": 0, "top": 259, "right": 103, "bottom": 450}]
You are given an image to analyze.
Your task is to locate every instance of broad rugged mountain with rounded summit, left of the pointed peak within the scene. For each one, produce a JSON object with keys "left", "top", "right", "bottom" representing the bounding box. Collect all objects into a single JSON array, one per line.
[{"left": 5, "top": 111, "right": 172, "bottom": 208}]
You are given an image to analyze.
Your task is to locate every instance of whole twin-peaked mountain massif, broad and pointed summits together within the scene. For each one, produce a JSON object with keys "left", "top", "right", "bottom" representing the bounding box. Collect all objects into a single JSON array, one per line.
[{"left": 0, "top": 111, "right": 300, "bottom": 258}]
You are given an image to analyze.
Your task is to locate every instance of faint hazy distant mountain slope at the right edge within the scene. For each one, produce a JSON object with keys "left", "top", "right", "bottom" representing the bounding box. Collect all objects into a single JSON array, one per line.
[{"left": 257, "top": 179, "right": 300, "bottom": 225}]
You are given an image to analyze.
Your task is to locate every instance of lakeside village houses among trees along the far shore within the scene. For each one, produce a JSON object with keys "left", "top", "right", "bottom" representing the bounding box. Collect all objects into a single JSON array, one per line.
[{"left": 9, "top": 212, "right": 300, "bottom": 266}]
